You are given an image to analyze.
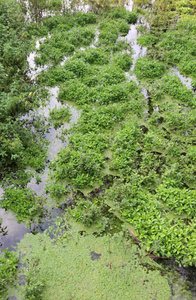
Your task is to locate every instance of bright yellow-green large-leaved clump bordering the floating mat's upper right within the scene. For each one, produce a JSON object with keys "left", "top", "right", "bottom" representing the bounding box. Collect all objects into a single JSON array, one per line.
[{"left": 107, "top": 181, "right": 195, "bottom": 265}]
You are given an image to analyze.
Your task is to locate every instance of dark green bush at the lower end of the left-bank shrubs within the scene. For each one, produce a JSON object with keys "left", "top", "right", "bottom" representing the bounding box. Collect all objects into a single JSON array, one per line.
[{"left": 0, "top": 118, "right": 47, "bottom": 169}]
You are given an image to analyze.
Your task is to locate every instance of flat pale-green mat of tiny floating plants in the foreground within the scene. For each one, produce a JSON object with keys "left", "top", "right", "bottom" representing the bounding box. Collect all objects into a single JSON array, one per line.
[{"left": 19, "top": 231, "right": 171, "bottom": 300}]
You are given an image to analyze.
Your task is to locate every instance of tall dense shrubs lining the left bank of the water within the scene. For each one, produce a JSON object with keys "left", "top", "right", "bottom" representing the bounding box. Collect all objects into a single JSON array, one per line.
[{"left": 0, "top": 0, "right": 46, "bottom": 177}]
